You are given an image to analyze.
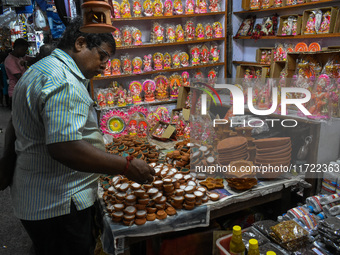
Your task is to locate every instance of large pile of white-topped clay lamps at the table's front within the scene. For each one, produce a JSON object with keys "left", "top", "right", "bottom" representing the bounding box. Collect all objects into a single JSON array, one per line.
[{"left": 102, "top": 163, "right": 219, "bottom": 226}]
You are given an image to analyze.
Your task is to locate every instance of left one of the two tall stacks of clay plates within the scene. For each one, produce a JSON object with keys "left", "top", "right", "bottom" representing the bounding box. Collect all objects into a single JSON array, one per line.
[{"left": 217, "top": 136, "right": 249, "bottom": 165}]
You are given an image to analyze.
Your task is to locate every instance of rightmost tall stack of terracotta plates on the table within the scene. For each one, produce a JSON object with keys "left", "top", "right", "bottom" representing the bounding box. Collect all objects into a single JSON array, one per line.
[{"left": 253, "top": 137, "right": 292, "bottom": 178}]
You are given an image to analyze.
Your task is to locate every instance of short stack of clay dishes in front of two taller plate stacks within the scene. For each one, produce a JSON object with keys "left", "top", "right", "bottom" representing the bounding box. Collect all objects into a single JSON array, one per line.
[{"left": 227, "top": 160, "right": 257, "bottom": 190}]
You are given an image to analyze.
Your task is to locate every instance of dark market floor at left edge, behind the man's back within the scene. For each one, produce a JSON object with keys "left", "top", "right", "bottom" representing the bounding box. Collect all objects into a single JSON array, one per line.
[{"left": 0, "top": 107, "right": 32, "bottom": 255}]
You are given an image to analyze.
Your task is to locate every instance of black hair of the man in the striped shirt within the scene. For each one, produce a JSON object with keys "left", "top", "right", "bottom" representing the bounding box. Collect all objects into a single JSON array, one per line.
[{"left": 57, "top": 17, "right": 116, "bottom": 53}]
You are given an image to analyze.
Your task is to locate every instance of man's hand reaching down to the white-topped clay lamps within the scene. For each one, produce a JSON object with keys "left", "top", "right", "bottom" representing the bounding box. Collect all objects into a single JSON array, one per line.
[{"left": 125, "top": 159, "right": 156, "bottom": 184}]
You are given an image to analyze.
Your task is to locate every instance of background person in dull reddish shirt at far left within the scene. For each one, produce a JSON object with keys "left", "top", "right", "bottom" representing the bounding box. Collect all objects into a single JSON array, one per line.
[{"left": 5, "top": 38, "right": 29, "bottom": 108}]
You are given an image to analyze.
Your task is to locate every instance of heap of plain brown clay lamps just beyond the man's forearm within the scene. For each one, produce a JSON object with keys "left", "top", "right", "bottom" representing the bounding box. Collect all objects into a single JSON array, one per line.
[{"left": 106, "top": 135, "right": 159, "bottom": 163}]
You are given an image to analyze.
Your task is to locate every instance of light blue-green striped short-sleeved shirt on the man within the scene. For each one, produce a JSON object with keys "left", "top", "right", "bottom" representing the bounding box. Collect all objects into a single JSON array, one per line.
[{"left": 11, "top": 49, "right": 105, "bottom": 220}]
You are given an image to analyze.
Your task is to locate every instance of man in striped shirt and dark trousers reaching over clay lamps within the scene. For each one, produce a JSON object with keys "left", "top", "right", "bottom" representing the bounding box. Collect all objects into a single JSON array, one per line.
[{"left": 1, "top": 16, "right": 155, "bottom": 255}]
